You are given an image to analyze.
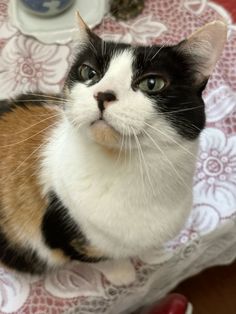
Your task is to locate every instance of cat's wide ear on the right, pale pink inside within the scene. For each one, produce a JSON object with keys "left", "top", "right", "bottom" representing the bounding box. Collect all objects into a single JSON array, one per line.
[{"left": 177, "top": 21, "right": 227, "bottom": 83}]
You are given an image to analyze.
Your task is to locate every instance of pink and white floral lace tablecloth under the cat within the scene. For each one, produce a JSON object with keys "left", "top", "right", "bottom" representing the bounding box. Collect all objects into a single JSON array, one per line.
[{"left": 0, "top": 0, "right": 236, "bottom": 314}]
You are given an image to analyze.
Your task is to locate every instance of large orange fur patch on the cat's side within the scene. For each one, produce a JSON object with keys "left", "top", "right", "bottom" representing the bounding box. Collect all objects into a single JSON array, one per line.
[{"left": 0, "top": 103, "right": 59, "bottom": 249}]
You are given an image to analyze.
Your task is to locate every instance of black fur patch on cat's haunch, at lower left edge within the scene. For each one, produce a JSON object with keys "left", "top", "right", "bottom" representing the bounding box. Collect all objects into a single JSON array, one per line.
[{"left": 0, "top": 224, "right": 47, "bottom": 274}]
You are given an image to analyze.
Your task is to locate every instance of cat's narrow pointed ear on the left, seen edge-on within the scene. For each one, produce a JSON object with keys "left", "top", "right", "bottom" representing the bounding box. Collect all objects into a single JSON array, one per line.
[{"left": 74, "top": 11, "right": 100, "bottom": 44}]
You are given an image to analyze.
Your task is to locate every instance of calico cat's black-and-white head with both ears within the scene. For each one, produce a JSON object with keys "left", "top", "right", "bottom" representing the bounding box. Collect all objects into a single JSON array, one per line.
[{"left": 65, "top": 15, "right": 227, "bottom": 149}]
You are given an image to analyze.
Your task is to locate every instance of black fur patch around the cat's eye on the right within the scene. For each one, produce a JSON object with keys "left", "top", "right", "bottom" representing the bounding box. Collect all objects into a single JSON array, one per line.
[{"left": 133, "top": 46, "right": 207, "bottom": 140}]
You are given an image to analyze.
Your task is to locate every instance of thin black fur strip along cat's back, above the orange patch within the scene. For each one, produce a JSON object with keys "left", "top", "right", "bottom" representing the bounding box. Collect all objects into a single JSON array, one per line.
[{"left": 0, "top": 93, "right": 60, "bottom": 117}]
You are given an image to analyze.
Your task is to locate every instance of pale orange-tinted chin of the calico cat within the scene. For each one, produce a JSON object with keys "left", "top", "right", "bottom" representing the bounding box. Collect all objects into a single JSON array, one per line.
[{"left": 89, "top": 120, "right": 121, "bottom": 149}]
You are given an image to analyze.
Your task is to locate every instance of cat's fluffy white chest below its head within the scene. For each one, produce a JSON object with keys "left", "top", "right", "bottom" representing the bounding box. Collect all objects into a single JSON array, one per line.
[{"left": 43, "top": 121, "right": 192, "bottom": 258}]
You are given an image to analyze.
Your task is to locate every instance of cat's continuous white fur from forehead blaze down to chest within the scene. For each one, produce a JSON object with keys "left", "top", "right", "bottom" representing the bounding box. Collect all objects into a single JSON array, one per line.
[{"left": 41, "top": 50, "right": 198, "bottom": 264}]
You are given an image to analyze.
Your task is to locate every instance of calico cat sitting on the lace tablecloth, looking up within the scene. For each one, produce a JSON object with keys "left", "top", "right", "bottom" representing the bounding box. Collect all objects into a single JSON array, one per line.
[{"left": 0, "top": 15, "right": 227, "bottom": 273}]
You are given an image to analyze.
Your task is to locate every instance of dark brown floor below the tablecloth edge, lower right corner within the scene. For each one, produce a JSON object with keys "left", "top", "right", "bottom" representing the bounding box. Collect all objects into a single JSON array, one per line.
[{"left": 175, "top": 263, "right": 236, "bottom": 314}]
